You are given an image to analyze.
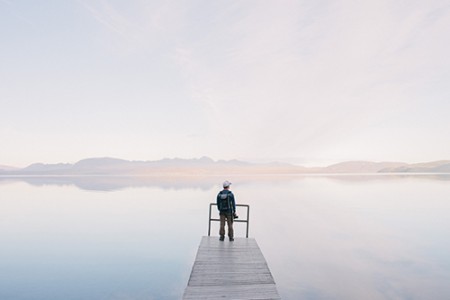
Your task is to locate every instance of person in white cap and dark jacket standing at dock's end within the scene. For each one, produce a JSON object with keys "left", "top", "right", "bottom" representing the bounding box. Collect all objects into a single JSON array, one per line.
[{"left": 217, "top": 180, "right": 236, "bottom": 242}]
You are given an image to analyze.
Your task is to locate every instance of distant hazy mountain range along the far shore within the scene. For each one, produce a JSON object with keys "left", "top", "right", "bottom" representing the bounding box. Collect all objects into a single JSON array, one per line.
[{"left": 0, "top": 157, "right": 450, "bottom": 176}]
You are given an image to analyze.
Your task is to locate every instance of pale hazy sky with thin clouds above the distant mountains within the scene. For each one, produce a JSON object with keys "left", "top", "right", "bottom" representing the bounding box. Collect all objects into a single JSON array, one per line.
[{"left": 0, "top": 0, "right": 450, "bottom": 167}]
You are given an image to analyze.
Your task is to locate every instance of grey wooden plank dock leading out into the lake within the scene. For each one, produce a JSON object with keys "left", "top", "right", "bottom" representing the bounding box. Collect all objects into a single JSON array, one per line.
[{"left": 183, "top": 236, "right": 281, "bottom": 300}]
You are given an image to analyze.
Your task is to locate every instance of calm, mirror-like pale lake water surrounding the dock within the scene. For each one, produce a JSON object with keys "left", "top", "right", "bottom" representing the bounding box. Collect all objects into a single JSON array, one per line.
[{"left": 0, "top": 176, "right": 450, "bottom": 300}]
